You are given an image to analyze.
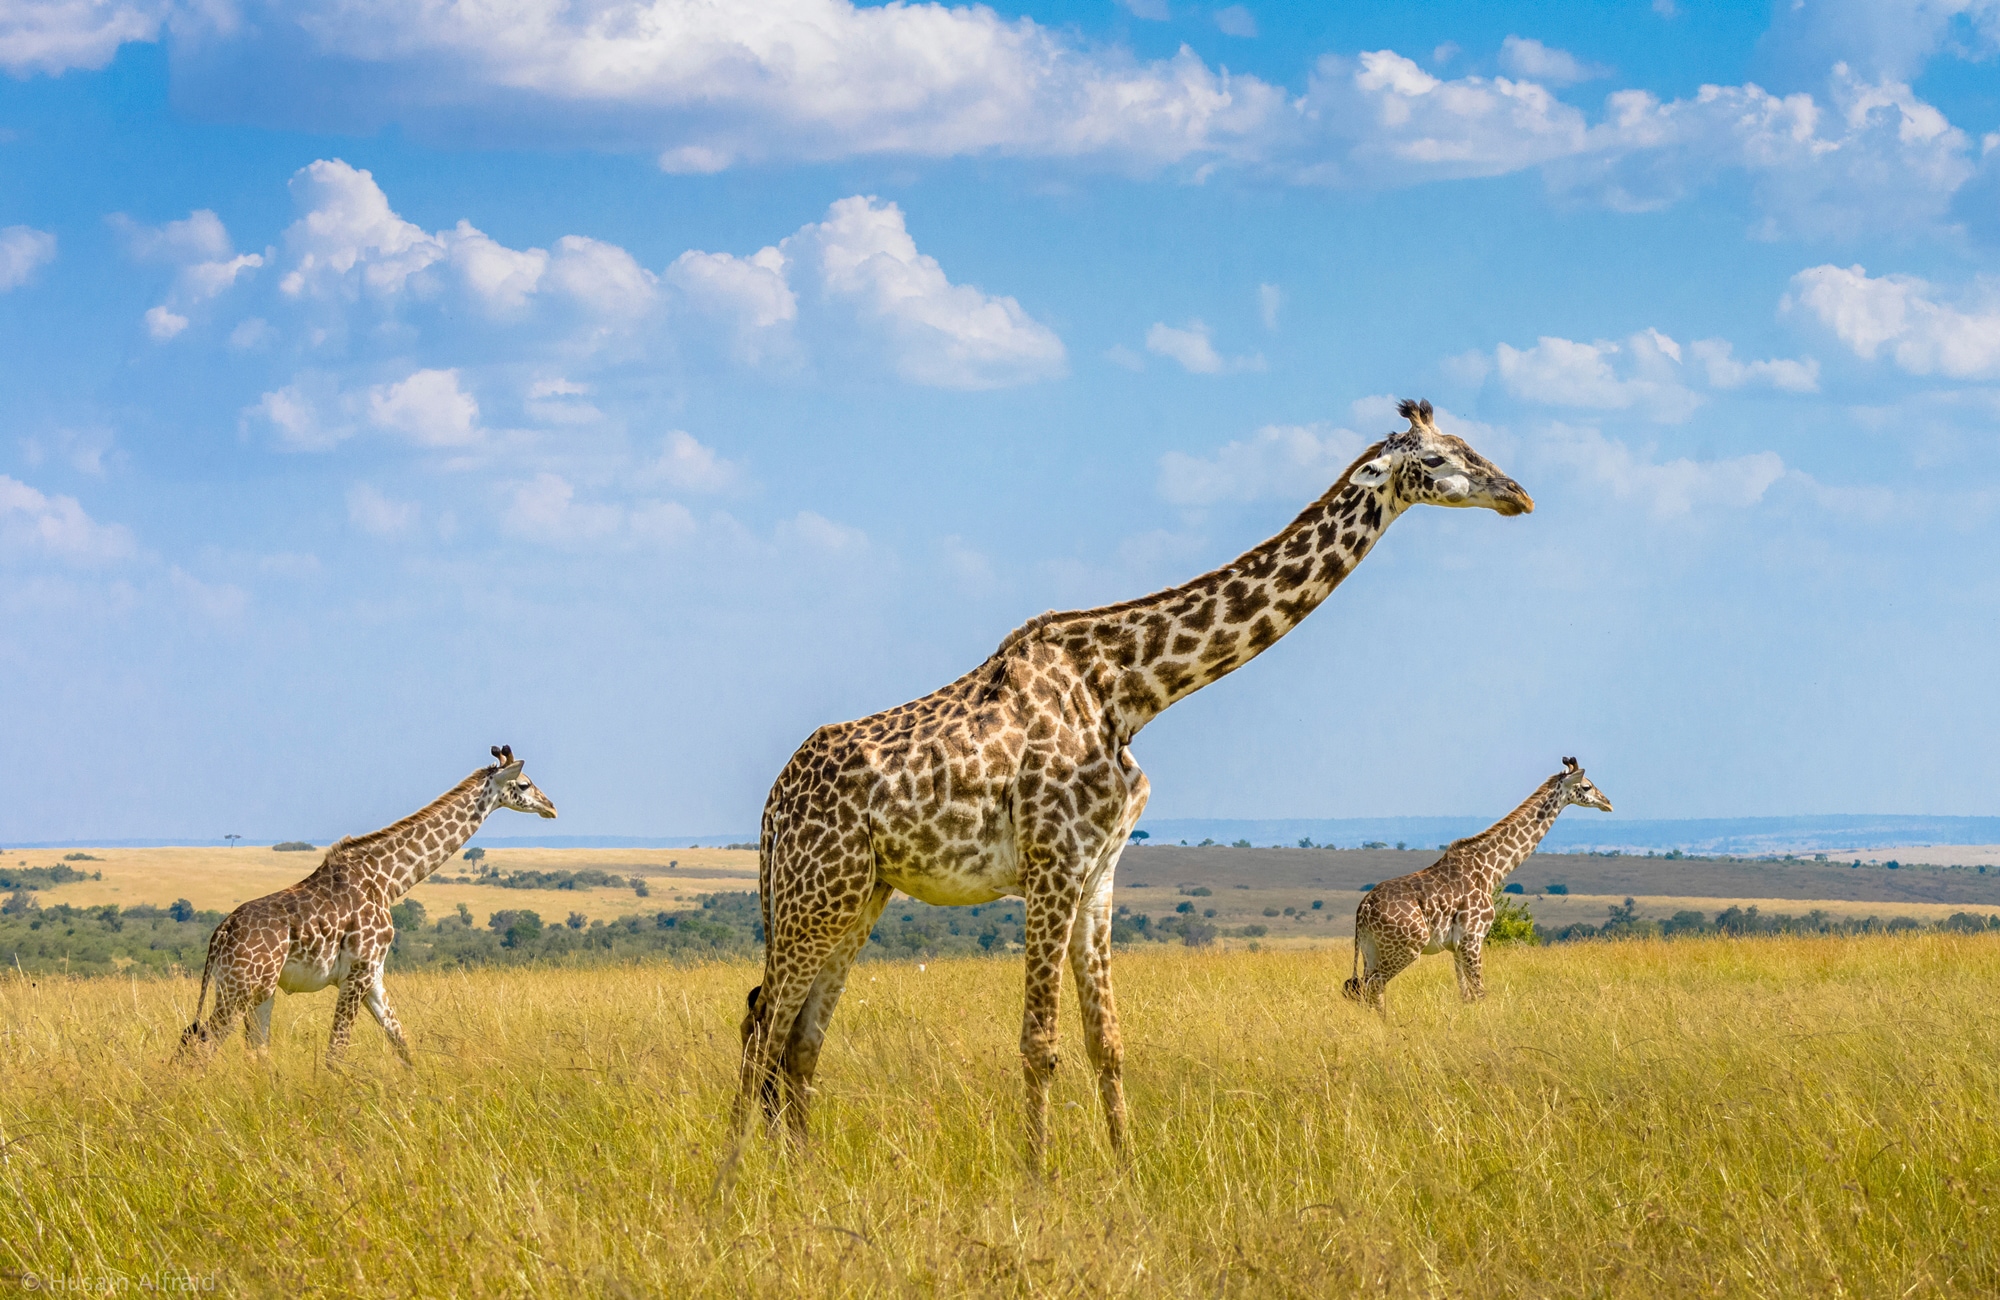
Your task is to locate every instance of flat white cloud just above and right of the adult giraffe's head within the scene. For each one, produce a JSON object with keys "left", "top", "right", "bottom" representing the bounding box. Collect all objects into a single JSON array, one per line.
[{"left": 1496, "top": 328, "right": 1820, "bottom": 424}]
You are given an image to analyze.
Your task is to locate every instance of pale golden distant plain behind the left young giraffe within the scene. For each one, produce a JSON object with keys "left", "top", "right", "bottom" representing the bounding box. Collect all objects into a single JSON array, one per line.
[{"left": 8, "top": 844, "right": 756, "bottom": 924}]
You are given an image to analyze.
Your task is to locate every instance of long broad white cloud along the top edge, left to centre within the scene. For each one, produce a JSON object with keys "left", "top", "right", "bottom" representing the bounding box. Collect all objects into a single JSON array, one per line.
[{"left": 160, "top": 0, "right": 1288, "bottom": 174}]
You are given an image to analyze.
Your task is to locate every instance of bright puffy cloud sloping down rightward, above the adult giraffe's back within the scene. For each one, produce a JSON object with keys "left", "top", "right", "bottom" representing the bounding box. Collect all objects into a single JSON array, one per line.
[{"left": 780, "top": 196, "right": 1066, "bottom": 388}]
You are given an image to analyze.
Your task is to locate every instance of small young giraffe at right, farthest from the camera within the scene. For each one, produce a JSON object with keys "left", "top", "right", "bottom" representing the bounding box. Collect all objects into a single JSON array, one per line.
[{"left": 1340, "top": 758, "right": 1612, "bottom": 1014}]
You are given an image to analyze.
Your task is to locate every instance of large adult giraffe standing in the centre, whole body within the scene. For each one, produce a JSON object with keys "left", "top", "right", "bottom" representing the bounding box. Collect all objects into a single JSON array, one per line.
[{"left": 732, "top": 402, "right": 1534, "bottom": 1190}]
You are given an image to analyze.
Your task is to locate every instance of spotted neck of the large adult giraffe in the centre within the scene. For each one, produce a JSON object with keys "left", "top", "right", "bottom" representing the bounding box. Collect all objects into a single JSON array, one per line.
[{"left": 1046, "top": 442, "right": 1402, "bottom": 728}]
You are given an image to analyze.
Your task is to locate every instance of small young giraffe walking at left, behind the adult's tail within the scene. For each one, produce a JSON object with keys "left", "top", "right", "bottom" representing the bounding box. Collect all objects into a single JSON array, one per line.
[{"left": 180, "top": 746, "right": 556, "bottom": 1066}]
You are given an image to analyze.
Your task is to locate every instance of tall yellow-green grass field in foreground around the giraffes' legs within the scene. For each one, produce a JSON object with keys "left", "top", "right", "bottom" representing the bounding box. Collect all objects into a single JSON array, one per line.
[{"left": 0, "top": 934, "right": 2000, "bottom": 1296}]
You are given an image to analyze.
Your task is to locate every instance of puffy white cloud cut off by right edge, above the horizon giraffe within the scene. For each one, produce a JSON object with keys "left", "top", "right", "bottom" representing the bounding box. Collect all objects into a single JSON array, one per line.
[{"left": 1786, "top": 264, "right": 2000, "bottom": 380}]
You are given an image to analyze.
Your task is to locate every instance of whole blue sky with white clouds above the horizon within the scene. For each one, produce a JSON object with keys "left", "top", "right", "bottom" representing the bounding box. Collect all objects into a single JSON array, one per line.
[{"left": 0, "top": 0, "right": 2000, "bottom": 842}]
